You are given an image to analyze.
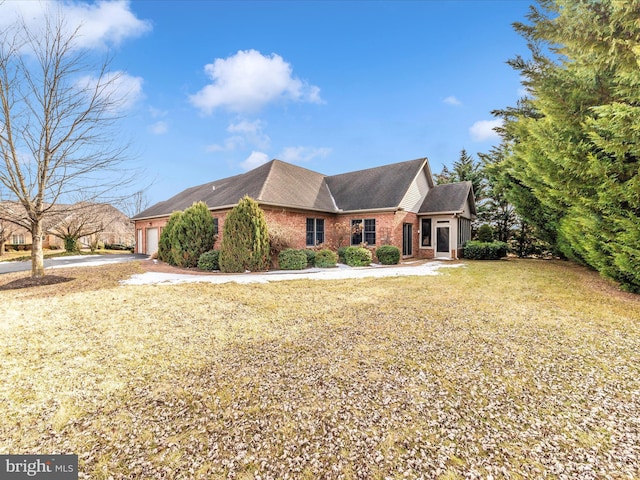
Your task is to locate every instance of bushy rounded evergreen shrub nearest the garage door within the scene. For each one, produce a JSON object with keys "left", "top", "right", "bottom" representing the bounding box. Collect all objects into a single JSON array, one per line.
[{"left": 170, "top": 202, "right": 216, "bottom": 268}]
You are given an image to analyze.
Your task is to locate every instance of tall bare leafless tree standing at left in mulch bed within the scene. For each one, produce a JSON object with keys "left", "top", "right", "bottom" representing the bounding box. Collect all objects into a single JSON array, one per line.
[{"left": 0, "top": 13, "right": 132, "bottom": 277}]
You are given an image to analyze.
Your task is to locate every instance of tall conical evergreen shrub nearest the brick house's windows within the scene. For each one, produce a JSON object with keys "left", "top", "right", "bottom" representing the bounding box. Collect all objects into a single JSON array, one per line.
[{"left": 220, "top": 196, "right": 270, "bottom": 272}]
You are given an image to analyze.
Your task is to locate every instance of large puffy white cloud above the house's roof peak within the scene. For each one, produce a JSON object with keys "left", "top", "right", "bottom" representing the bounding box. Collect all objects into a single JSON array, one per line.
[{"left": 189, "top": 50, "right": 322, "bottom": 114}]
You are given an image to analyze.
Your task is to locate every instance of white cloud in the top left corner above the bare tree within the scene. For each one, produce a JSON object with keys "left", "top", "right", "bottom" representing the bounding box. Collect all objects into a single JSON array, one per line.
[{"left": 0, "top": 0, "right": 151, "bottom": 48}]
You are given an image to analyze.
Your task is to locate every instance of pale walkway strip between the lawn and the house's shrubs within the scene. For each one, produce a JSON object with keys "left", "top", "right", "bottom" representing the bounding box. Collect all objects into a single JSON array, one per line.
[{"left": 120, "top": 261, "right": 463, "bottom": 285}]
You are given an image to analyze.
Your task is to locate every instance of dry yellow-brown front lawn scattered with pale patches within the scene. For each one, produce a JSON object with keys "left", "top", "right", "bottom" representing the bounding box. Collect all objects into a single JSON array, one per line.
[{"left": 0, "top": 261, "right": 640, "bottom": 479}]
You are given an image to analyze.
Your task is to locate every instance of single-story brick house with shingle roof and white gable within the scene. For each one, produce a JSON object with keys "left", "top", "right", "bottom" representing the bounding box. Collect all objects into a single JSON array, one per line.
[{"left": 133, "top": 158, "right": 476, "bottom": 258}]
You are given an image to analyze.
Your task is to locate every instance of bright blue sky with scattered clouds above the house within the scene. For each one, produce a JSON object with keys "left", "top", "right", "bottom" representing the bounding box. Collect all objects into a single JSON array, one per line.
[{"left": 0, "top": 0, "right": 533, "bottom": 205}]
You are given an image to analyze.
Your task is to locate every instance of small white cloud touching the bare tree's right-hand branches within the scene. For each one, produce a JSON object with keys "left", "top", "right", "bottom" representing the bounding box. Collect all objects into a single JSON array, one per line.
[{"left": 77, "top": 71, "right": 143, "bottom": 111}]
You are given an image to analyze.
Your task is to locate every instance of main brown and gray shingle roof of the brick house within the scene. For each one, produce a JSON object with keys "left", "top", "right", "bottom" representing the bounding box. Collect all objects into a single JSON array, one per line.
[{"left": 133, "top": 158, "right": 466, "bottom": 220}]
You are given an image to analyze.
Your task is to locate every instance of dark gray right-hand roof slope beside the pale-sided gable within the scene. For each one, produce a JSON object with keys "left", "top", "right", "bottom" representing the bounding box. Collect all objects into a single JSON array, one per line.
[{"left": 327, "top": 158, "right": 427, "bottom": 210}]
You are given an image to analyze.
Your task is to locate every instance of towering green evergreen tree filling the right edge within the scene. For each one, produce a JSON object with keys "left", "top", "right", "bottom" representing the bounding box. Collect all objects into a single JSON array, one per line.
[{"left": 499, "top": 0, "right": 640, "bottom": 291}]
